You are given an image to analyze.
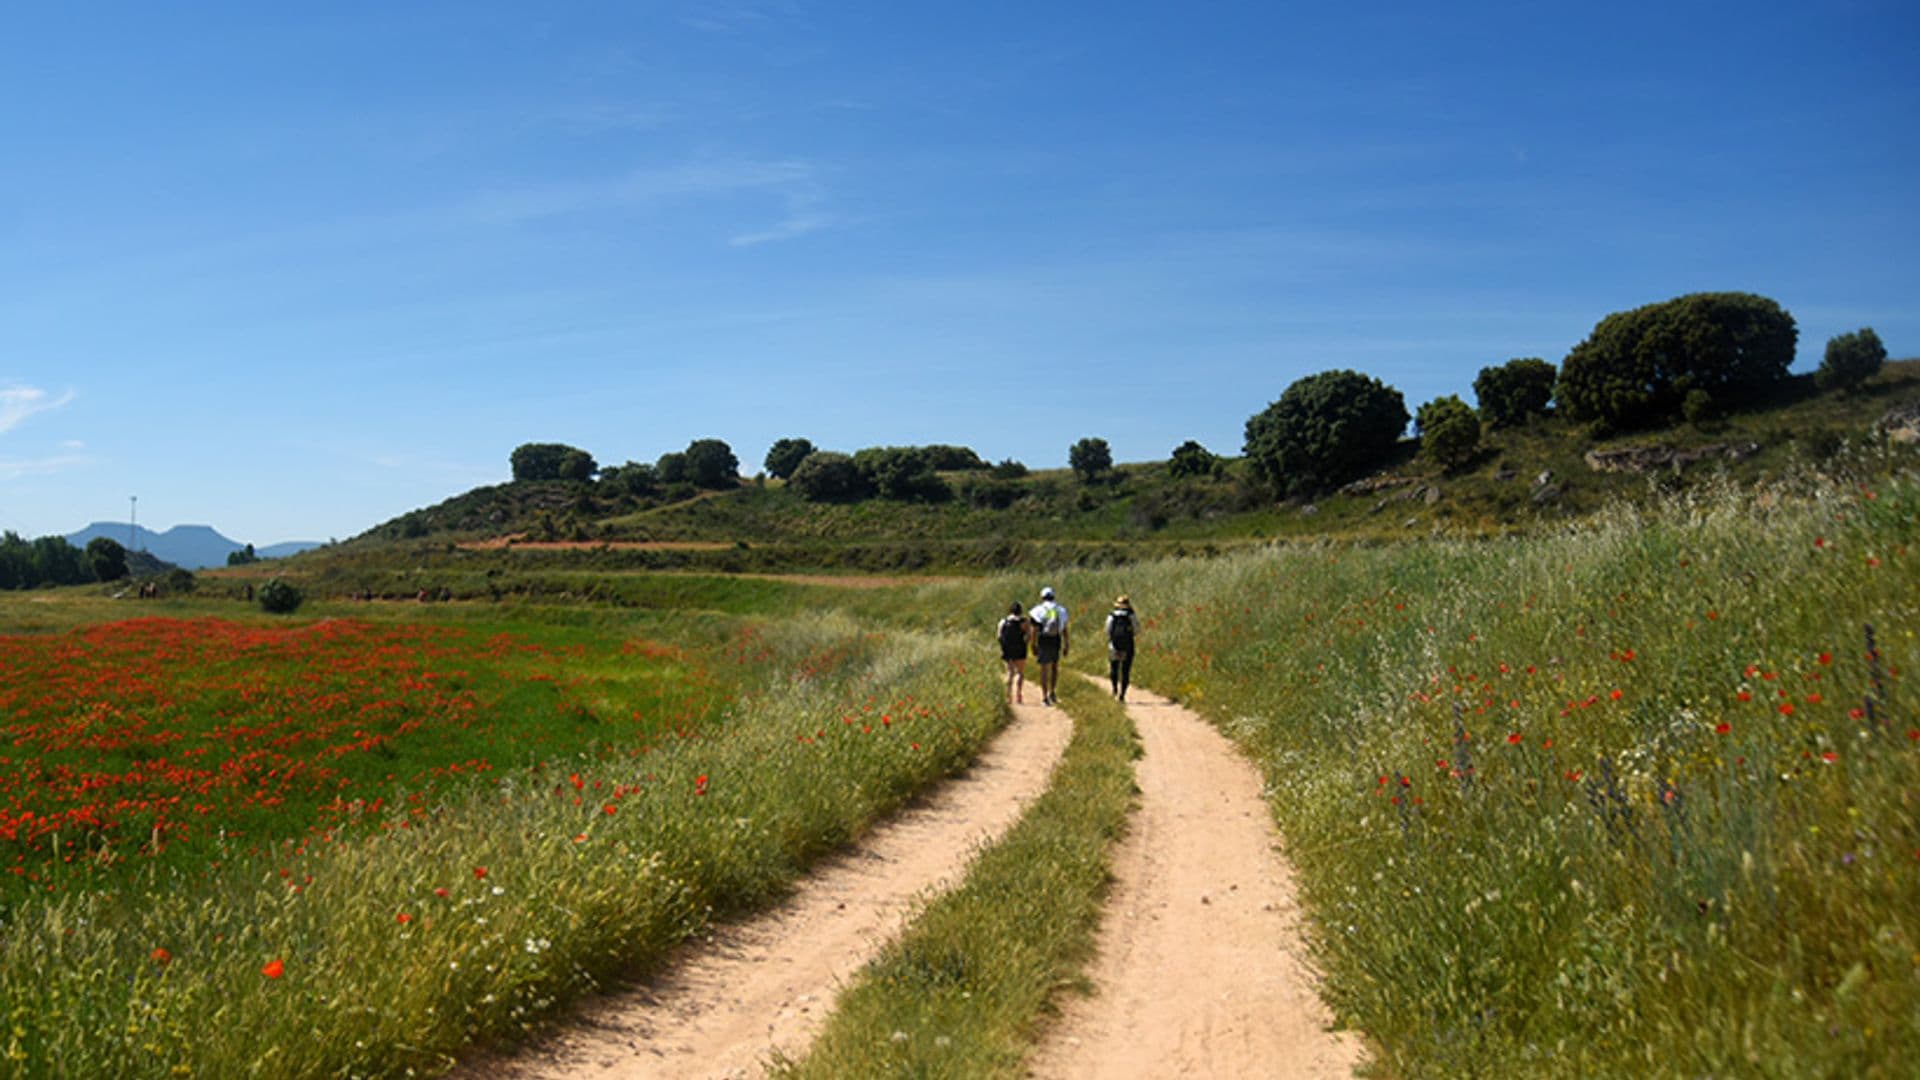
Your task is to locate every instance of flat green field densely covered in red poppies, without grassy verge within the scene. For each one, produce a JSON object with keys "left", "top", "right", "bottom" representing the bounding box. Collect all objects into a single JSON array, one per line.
[{"left": 0, "top": 619, "right": 720, "bottom": 903}]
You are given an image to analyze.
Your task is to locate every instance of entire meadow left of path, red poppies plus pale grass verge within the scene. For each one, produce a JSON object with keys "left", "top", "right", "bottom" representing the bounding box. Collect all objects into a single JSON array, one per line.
[{"left": 0, "top": 617, "right": 1004, "bottom": 1076}]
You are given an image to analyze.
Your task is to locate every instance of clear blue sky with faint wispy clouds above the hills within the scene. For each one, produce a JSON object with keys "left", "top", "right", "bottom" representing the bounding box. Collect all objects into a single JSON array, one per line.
[{"left": 0, "top": 0, "right": 1920, "bottom": 544}]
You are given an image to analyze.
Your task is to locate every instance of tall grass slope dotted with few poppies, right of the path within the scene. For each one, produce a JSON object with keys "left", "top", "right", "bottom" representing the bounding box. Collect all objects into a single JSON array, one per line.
[{"left": 1036, "top": 477, "right": 1920, "bottom": 1076}]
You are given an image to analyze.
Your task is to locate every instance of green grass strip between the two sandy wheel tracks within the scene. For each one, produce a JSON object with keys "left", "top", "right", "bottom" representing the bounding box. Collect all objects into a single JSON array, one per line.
[{"left": 780, "top": 680, "right": 1139, "bottom": 1078}]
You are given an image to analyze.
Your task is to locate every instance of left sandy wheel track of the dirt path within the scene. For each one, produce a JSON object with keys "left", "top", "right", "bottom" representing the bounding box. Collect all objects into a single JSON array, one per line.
[{"left": 455, "top": 691, "right": 1071, "bottom": 1080}]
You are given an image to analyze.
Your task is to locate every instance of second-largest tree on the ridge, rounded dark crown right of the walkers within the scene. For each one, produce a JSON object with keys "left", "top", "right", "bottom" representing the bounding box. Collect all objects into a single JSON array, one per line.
[{"left": 1246, "top": 371, "right": 1409, "bottom": 494}]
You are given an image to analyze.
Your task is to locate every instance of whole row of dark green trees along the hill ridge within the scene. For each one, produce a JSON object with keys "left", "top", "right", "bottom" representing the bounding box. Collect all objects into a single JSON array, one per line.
[{"left": 511, "top": 292, "right": 1887, "bottom": 502}]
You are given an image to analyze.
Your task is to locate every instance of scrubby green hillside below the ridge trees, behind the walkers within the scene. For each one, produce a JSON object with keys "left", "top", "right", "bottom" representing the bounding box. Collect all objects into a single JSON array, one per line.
[{"left": 318, "top": 359, "right": 1920, "bottom": 571}]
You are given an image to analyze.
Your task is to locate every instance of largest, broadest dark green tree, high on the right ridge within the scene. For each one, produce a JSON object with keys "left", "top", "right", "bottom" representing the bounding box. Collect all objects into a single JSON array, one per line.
[{"left": 1553, "top": 292, "right": 1799, "bottom": 429}]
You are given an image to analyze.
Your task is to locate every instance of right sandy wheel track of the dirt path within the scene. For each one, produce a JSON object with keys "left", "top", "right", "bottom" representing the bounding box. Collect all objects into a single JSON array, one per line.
[{"left": 1031, "top": 680, "right": 1361, "bottom": 1080}]
